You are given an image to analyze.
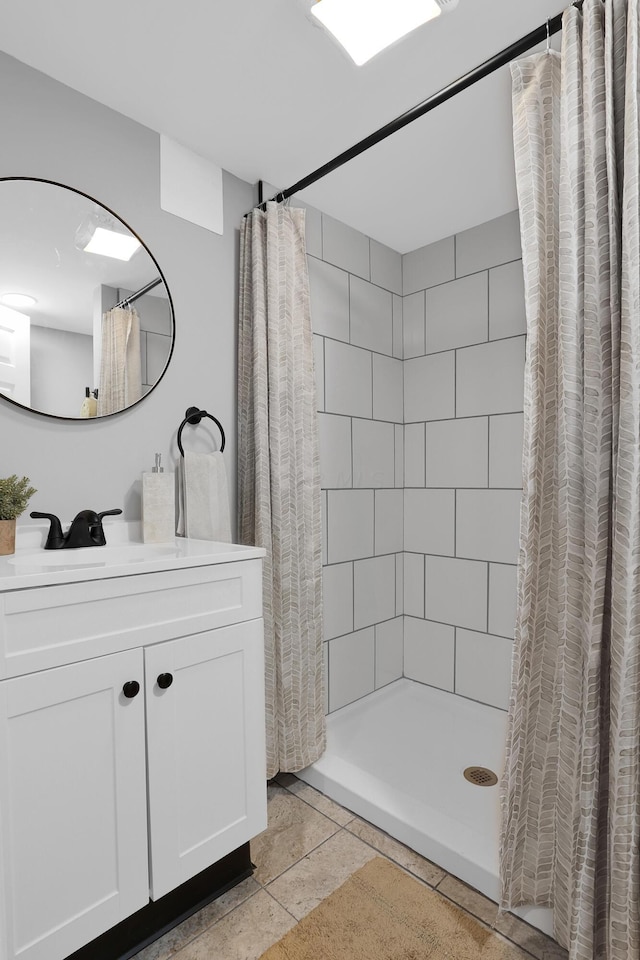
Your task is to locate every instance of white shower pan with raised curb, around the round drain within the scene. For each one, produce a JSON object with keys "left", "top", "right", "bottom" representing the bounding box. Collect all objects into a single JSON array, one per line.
[{"left": 296, "top": 679, "right": 551, "bottom": 933}]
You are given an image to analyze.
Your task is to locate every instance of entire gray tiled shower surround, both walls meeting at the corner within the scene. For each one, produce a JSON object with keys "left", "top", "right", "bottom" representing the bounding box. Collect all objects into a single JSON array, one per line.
[{"left": 307, "top": 201, "right": 525, "bottom": 711}]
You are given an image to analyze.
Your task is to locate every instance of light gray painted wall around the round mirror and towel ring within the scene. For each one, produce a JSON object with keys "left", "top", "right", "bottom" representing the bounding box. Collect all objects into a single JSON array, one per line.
[{"left": 0, "top": 54, "right": 254, "bottom": 522}]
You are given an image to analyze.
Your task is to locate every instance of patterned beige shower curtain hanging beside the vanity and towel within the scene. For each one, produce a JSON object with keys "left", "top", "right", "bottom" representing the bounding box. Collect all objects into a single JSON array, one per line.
[{"left": 238, "top": 202, "right": 325, "bottom": 777}]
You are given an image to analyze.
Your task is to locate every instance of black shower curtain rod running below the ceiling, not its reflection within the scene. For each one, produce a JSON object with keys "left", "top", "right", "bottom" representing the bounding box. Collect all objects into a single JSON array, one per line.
[{"left": 258, "top": 0, "right": 583, "bottom": 209}]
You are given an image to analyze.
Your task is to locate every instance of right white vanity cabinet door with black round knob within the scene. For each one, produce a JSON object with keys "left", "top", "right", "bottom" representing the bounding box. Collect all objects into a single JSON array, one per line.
[{"left": 144, "top": 620, "right": 267, "bottom": 900}]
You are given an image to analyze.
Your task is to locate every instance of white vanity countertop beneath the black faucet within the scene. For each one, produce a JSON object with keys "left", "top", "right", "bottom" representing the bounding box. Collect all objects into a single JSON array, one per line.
[{"left": 0, "top": 521, "right": 266, "bottom": 593}]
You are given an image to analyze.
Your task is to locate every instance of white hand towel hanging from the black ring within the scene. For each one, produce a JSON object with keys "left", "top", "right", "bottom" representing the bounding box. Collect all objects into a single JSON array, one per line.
[{"left": 178, "top": 450, "right": 231, "bottom": 543}]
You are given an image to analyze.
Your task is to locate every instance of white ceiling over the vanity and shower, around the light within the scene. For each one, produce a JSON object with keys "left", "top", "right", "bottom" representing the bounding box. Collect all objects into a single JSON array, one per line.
[{"left": 0, "top": 0, "right": 569, "bottom": 253}]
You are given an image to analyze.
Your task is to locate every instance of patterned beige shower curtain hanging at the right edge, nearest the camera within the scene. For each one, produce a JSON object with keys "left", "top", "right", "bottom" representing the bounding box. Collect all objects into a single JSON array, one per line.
[{"left": 501, "top": 0, "right": 640, "bottom": 960}]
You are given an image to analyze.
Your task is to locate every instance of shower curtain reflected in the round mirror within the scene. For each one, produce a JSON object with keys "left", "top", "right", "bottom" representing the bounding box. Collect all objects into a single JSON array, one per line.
[{"left": 98, "top": 307, "right": 142, "bottom": 417}]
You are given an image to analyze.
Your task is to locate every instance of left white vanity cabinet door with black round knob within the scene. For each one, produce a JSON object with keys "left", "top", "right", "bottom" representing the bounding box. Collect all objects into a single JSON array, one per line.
[{"left": 0, "top": 650, "right": 149, "bottom": 960}]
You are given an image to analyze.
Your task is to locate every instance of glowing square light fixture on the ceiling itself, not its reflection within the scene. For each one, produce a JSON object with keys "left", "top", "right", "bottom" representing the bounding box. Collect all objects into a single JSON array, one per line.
[{"left": 311, "top": 0, "right": 442, "bottom": 66}]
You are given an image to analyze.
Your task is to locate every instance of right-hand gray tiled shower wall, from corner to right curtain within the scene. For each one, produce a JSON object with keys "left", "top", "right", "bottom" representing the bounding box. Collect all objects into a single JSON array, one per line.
[{"left": 403, "top": 212, "right": 526, "bottom": 708}]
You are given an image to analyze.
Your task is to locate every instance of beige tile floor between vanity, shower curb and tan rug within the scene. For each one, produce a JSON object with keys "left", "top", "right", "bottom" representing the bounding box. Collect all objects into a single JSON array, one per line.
[{"left": 134, "top": 774, "right": 567, "bottom": 960}]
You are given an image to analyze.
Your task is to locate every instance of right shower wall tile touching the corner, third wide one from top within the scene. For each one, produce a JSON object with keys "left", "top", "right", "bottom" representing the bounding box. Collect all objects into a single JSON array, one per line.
[{"left": 404, "top": 490, "right": 455, "bottom": 555}]
